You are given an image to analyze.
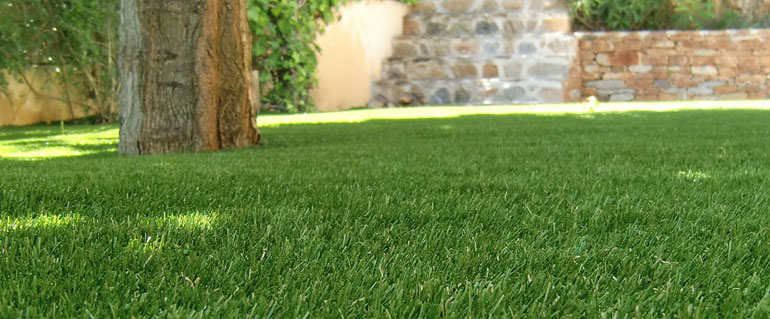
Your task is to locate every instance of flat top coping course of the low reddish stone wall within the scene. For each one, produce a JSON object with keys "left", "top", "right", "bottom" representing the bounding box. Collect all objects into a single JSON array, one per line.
[{"left": 574, "top": 29, "right": 770, "bottom": 40}]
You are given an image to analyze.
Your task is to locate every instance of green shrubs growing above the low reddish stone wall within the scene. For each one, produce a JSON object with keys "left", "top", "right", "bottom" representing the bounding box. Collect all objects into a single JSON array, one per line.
[{"left": 571, "top": 0, "right": 755, "bottom": 30}]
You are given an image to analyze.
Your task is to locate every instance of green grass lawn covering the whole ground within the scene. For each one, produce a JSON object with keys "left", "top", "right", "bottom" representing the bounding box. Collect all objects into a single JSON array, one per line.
[{"left": 0, "top": 104, "right": 770, "bottom": 318}]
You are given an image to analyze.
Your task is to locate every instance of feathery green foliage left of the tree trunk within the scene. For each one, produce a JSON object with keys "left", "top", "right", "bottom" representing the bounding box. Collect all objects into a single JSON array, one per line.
[{"left": 0, "top": 0, "right": 119, "bottom": 122}]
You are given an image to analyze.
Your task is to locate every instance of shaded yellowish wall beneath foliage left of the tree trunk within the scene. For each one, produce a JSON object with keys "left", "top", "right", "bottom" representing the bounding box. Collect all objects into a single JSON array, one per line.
[{"left": 0, "top": 67, "right": 91, "bottom": 126}]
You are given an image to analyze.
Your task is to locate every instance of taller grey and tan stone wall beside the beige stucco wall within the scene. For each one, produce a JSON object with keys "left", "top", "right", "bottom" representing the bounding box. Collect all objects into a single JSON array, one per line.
[{"left": 369, "top": 0, "right": 577, "bottom": 107}]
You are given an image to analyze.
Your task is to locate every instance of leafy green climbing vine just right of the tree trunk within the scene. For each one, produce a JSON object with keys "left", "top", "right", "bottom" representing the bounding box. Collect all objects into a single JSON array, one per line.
[{"left": 249, "top": 0, "right": 416, "bottom": 111}]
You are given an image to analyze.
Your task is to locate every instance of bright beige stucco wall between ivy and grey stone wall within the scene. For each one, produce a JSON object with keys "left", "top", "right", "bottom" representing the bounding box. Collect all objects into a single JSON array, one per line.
[{"left": 311, "top": 0, "right": 408, "bottom": 111}]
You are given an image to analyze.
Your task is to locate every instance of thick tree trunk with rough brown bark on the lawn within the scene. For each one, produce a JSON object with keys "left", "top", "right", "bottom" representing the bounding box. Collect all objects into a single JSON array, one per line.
[{"left": 119, "top": 0, "right": 259, "bottom": 154}]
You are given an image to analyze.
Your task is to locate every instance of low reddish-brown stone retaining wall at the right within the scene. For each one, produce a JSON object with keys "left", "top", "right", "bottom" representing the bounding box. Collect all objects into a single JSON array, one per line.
[{"left": 567, "top": 30, "right": 770, "bottom": 101}]
